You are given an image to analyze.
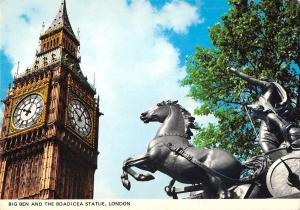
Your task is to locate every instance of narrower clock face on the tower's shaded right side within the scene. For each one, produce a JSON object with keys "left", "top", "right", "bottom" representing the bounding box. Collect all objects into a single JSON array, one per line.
[{"left": 69, "top": 100, "right": 92, "bottom": 137}]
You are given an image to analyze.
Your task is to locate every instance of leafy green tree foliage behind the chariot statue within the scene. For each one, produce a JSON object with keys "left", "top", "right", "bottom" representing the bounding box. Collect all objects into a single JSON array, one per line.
[{"left": 182, "top": 0, "right": 300, "bottom": 158}]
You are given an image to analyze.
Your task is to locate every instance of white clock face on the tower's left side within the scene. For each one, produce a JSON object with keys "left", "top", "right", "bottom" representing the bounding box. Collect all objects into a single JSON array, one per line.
[{"left": 13, "top": 94, "right": 43, "bottom": 129}]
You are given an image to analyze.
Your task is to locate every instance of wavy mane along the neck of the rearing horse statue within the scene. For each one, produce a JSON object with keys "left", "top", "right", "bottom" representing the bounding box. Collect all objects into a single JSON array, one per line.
[{"left": 157, "top": 100, "right": 199, "bottom": 139}]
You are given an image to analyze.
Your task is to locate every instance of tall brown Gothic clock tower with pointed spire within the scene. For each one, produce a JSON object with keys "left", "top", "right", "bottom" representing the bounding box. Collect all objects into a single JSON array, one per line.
[{"left": 0, "top": 0, "right": 100, "bottom": 199}]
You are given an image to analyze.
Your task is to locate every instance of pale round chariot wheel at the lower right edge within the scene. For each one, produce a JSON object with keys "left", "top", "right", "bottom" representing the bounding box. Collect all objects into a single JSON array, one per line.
[{"left": 266, "top": 151, "right": 300, "bottom": 197}]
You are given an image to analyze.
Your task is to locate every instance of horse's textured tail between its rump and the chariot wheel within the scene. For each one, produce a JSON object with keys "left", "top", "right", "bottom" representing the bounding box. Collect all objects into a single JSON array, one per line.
[{"left": 239, "top": 155, "right": 268, "bottom": 183}]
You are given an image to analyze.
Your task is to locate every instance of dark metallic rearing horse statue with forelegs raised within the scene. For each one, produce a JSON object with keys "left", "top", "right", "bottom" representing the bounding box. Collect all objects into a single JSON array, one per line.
[{"left": 121, "top": 101, "right": 243, "bottom": 198}]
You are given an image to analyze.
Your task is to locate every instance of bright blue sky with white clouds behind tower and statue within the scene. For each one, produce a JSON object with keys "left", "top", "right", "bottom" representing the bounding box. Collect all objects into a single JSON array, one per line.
[{"left": 0, "top": 0, "right": 228, "bottom": 198}]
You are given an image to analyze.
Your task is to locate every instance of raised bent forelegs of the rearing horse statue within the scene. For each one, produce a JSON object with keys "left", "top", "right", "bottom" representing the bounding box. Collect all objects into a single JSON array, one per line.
[{"left": 121, "top": 155, "right": 154, "bottom": 190}]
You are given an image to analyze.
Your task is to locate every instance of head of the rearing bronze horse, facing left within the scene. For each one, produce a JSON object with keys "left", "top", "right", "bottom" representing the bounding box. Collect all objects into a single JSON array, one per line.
[{"left": 140, "top": 101, "right": 178, "bottom": 123}]
